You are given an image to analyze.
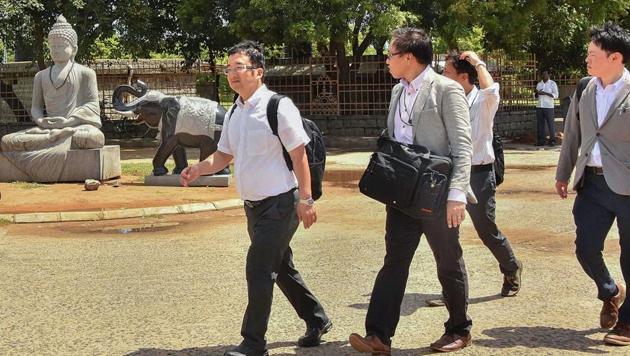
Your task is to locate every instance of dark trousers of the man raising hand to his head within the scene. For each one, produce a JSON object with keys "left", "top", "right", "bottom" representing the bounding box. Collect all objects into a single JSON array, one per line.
[{"left": 466, "top": 164, "right": 518, "bottom": 274}]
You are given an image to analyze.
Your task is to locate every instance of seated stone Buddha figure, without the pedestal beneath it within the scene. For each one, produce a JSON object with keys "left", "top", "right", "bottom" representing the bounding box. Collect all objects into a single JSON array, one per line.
[{"left": 1, "top": 16, "right": 105, "bottom": 152}]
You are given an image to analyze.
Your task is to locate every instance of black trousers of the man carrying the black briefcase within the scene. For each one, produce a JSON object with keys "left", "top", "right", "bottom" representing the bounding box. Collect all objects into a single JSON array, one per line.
[{"left": 365, "top": 207, "right": 472, "bottom": 344}]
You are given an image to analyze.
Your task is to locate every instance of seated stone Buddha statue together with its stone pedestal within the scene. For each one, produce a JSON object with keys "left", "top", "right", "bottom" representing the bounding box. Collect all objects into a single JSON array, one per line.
[{"left": 0, "top": 16, "right": 120, "bottom": 182}]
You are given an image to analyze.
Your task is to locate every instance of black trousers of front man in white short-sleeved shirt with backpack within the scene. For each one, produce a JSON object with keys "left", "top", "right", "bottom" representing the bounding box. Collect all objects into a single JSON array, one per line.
[{"left": 241, "top": 190, "right": 328, "bottom": 350}]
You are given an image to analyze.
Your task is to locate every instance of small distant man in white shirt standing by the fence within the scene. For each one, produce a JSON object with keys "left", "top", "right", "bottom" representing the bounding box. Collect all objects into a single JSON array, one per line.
[{"left": 535, "top": 71, "right": 558, "bottom": 146}]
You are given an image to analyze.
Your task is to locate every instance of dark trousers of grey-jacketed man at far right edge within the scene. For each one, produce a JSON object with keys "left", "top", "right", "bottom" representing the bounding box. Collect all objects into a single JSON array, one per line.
[{"left": 573, "top": 167, "right": 630, "bottom": 323}]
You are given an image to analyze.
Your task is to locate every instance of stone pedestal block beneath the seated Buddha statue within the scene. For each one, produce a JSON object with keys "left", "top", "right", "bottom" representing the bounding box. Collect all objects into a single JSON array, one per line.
[{"left": 0, "top": 146, "right": 121, "bottom": 182}]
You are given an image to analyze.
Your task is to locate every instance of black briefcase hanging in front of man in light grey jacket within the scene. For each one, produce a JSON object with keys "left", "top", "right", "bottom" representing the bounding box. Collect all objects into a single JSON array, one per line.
[{"left": 359, "top": 133, "right": 453, "bottom": 218}]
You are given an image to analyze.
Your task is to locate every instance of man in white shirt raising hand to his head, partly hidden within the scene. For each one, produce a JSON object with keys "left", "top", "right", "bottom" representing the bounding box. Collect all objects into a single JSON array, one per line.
[{"left": 444, "top": 51, "right": 523, "bottom": 297}]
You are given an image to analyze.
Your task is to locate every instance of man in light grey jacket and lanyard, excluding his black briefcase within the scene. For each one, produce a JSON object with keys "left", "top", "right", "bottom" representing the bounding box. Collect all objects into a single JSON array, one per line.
[{"left": 349, "top": 28, "right": 476, "bottom": 355}]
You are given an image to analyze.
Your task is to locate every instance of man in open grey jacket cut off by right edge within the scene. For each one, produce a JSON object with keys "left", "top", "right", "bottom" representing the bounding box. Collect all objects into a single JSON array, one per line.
[{"left": 556, "top": 23, "right": 630, "bottom": 345}]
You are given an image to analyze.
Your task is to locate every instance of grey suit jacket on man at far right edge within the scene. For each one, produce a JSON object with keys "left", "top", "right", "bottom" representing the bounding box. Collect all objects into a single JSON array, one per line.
[{"left": 556, "top": 73, "right": 630, "bottom": 195}]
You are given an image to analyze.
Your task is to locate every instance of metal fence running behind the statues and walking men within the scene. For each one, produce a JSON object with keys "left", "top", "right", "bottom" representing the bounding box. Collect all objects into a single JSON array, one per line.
[{"left": 0, "top": 55, "right": 578, "bottom": 128}]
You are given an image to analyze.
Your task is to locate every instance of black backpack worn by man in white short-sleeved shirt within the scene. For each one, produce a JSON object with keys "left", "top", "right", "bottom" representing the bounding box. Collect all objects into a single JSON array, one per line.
[{"left": 267, "top": 94, "right": 326, "bottom": 200}]
